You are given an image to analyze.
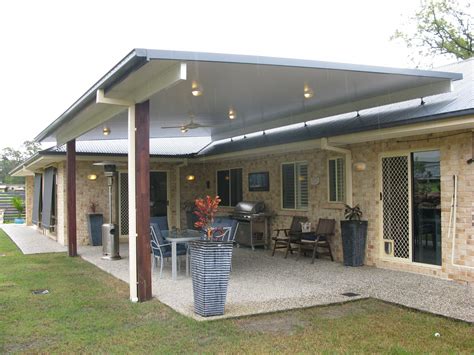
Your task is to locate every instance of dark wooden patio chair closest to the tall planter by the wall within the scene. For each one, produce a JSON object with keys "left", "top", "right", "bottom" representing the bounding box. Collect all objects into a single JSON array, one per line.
[{"left": 298, "top": 218, "right": 336, "bottom": 264}]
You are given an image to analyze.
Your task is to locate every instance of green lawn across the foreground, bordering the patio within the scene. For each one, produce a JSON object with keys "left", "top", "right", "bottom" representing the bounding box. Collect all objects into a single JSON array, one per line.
[{"left": 0, "top": 230, "right": 474, "bottom": 354}]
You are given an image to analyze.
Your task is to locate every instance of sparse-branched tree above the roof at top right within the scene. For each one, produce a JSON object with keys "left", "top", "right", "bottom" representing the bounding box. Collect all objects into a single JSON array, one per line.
[{"left": 391, "top": 0, "right": 474, "bottom": 65}]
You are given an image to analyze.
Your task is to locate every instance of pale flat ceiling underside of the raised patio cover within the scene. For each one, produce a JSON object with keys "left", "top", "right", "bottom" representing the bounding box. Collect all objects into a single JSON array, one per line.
[{"left": 52, "top": 56, "right": 451, "bottom": 143}]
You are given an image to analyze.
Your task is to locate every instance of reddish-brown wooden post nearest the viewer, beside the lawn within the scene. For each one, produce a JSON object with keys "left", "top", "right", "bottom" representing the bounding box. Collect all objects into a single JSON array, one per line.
[{"left": 135, "top": 101, "right": 151, "bottom": 302}]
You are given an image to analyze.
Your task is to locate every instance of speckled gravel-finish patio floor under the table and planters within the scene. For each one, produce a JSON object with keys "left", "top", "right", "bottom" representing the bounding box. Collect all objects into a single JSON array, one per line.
[{"left": 79, "top": 244, "right": 474, "bottom": 322}]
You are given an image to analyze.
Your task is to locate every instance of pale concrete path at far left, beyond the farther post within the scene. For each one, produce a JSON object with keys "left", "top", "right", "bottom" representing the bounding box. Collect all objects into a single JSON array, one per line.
[{"left": 0, "top": 224, "right": 67, "bottom": 254}]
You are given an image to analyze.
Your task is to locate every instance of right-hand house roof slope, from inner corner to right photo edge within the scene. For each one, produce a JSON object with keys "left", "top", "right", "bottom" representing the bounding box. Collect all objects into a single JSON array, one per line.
[{"left": 199, "top": 59, "right": 474, "bottom": 156}]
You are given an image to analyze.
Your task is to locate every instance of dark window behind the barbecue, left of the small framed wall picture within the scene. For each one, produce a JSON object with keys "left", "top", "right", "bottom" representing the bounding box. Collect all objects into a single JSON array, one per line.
[{"left": 217, "top": 169, "right": 243, "bottom": 206}]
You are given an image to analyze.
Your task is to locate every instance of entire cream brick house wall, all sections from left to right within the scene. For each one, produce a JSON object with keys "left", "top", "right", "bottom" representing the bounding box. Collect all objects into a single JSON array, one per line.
[{"left": 31, "top": 131, "right": 474, "bottom": 282}]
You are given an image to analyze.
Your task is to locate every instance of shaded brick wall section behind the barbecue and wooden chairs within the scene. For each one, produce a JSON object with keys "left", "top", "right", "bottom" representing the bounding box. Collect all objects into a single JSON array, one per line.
[{"left": 181, "top": 149, "right": 344, "bottom": 260}]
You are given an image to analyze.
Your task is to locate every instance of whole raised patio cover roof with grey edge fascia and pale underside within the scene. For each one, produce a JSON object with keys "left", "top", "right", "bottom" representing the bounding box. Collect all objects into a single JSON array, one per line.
[{"left": 36, "top": 49, "right": 462, "bottom": 144}]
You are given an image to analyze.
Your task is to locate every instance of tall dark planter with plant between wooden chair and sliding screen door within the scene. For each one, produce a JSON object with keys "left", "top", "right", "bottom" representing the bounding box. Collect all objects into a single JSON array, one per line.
[{"left": 341, "top": 205, "right": 368, "bottom": 266}]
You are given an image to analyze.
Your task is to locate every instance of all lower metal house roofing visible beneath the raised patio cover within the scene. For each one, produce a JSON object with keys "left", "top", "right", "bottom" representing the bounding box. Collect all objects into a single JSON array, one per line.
[{"left": 26, "top": 59, "right": 474, "bottom": 161}]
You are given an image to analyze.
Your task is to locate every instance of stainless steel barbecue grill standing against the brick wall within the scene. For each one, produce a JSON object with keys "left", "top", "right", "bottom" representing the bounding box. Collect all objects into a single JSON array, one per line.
[{"left": 231, "top": 201, "right": 269, "bottom": 249}]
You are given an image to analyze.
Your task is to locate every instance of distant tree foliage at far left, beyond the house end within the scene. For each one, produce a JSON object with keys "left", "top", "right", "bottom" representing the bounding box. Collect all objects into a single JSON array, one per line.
[{"left": 0, "top": 141, "right": 41, "bottom": 184}]
